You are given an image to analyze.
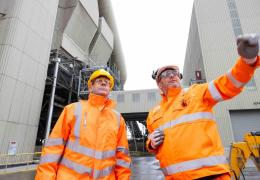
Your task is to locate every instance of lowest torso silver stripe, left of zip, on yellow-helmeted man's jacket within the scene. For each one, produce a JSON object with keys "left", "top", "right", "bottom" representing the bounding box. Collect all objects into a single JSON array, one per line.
[{"left": 60, "top": 157, "right": 93, "bottom": 175}]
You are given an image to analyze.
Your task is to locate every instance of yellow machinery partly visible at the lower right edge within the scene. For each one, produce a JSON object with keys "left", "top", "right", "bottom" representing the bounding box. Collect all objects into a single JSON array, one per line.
[{"left": 229, "top": 131, "right": 260, "bottom": 179}]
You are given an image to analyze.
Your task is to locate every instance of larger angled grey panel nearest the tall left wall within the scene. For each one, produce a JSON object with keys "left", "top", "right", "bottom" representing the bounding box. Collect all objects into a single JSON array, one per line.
[{"left": 62, "top": 1, "right": 99, "bottom": 60}]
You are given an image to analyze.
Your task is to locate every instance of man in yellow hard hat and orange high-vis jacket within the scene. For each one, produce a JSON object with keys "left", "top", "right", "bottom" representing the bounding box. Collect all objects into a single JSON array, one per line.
[{"left": 35, "top": 69, "right": 131, "bottom": 180}]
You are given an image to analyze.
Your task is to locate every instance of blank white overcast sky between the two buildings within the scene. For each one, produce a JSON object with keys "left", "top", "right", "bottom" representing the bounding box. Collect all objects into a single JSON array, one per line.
[{"left": 111, "top": 0, "right": 193, "bottom": 90}]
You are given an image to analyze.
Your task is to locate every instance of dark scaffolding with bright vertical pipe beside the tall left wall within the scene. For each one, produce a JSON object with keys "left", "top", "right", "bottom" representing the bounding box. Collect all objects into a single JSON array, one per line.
[{"left": 36, "top": 49, "right": 86, "bottom": 145}]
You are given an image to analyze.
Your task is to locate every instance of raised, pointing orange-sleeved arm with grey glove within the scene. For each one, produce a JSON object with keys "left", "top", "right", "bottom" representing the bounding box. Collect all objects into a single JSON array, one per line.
[{"left": 204, "top": 34, "right": 259, "bottom": 105}]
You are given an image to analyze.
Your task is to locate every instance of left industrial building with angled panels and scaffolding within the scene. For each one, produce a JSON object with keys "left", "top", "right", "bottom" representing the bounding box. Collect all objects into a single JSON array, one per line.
[{"left": 0, "top": 0, "right": 126, "bottom": 154}]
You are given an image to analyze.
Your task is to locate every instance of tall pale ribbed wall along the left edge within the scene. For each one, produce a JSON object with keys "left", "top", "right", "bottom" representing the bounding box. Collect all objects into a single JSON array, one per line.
[{"left": 0, "top": 0, "right": 58, "bottom": 154}]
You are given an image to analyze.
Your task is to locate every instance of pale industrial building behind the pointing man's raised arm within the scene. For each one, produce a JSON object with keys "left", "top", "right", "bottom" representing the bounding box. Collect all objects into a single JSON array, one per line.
[{"left": 183, "top": 0, "right": 260, "bottom": 147}]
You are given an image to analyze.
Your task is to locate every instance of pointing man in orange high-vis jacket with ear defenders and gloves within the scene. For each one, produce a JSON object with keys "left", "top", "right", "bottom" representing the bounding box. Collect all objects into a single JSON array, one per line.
[{"left": 147, "top": 34, "right": 259, "bottom": 180}]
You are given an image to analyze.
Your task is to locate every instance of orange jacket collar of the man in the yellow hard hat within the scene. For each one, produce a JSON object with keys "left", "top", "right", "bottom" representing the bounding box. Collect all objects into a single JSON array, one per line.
[{"left": 88, "top": 93, "right": 115, "bottom": 109}]
